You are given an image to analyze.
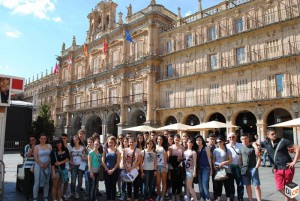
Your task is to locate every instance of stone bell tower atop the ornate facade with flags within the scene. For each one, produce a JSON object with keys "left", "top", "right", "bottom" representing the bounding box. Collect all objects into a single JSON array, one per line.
[{"left": 87, "top": 0, "right": 118, "bottom": 42}]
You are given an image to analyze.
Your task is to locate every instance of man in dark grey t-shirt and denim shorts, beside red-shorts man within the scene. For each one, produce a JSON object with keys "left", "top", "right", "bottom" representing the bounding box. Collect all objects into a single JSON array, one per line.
[{"left": 240, "top": 134, "right": 261, "bottom": 201}]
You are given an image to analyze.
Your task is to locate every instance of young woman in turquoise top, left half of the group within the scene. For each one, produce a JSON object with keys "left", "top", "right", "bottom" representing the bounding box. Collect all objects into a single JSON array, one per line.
[{"left": 88, "top": 139, "right": 102, "bottom": 201}]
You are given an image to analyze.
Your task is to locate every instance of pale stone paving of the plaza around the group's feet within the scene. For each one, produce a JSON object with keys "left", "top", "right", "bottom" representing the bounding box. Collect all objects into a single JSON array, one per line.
[{"left": 3, "top": 152, "right": 300, "bottom": 201}]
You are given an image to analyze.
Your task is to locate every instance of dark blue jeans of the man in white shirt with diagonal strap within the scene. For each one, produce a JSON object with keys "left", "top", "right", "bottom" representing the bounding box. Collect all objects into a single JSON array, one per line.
[{"left": 230, "top": 165, "right": 244, "bottom": 199}]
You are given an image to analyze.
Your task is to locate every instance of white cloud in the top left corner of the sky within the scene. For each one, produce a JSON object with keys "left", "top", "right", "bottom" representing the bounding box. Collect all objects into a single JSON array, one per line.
[{"left": 0, "top": 0, "right": 61, "bottom": 22}]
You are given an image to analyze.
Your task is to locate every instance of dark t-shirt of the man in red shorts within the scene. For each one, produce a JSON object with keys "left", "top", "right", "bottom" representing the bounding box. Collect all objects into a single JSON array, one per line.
[{"left": 260, "top": 138, "right": 293, "bottom": 170}]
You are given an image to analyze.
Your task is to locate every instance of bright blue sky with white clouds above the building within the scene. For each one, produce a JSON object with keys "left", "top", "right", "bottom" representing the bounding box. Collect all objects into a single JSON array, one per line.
[{"left": 0, "top": 0, "right": 222, "bottom": 81}]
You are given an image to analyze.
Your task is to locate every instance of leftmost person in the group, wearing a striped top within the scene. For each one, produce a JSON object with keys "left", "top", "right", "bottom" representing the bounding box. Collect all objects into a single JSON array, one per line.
[{"left": 22, "top": 136, "right": 36, "bottom": 200}]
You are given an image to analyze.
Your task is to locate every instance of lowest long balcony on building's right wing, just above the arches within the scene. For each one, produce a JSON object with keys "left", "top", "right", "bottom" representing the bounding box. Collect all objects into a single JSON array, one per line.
[{"left": 160, "top": 83, "right": 300, "bottom": 109}]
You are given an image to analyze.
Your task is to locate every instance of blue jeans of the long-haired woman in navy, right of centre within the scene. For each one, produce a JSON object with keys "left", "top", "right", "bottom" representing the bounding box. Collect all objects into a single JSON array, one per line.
[{"left": 198, "top": 167, "right": 210, "bottom": 200}]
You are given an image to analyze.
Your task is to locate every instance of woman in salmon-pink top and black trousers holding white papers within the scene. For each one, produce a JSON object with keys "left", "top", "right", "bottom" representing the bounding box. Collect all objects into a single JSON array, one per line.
[{"left": 123, "top": 138, "right": 141, "bottom": 201}]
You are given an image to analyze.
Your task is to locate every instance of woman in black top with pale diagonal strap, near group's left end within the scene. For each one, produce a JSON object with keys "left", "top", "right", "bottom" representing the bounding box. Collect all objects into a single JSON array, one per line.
[{"left": 51, "top": 139, "right": 70, "bottom": 201}]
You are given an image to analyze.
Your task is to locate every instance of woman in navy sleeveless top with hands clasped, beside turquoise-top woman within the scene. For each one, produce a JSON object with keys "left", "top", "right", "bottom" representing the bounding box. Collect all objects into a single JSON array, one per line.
[{"left": 102, "top": 136, "right": 121, "bottom": 201}]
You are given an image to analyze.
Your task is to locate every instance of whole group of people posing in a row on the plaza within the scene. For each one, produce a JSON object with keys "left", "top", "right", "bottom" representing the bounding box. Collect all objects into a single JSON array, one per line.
[{"left": 23, "top": 129, "right": 300, "bottom": 201}]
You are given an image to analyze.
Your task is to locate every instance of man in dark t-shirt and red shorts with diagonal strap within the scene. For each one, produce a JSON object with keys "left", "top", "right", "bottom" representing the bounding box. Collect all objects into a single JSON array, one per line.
[{"left": 253, "top": 128, "right": 300, "bottom": 201}]
